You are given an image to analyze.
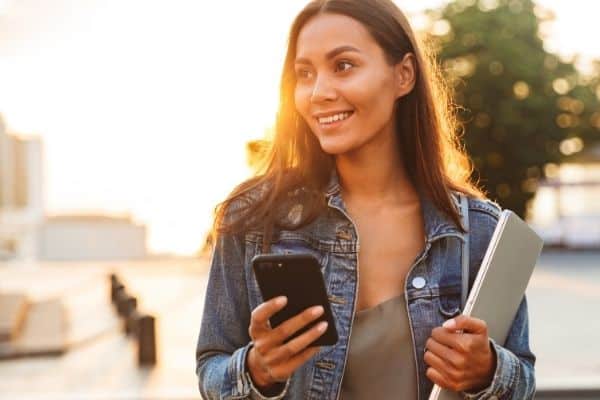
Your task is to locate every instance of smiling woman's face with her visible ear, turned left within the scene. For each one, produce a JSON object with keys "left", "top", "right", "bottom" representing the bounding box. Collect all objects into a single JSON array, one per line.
[{"left": 294, "top": 13, "right": 414, "bottom": 155}]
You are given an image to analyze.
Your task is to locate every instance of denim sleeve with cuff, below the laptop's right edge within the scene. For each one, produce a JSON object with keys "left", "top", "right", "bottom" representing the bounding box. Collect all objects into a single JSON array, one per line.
[{"left": 462, "top": 296, "right": 536, "bottom": 400}]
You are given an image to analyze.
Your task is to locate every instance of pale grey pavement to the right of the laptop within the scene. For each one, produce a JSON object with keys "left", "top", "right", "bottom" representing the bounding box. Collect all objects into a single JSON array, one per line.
[{"left": 526, "top": 251, "right": 600, "bottom": 389}]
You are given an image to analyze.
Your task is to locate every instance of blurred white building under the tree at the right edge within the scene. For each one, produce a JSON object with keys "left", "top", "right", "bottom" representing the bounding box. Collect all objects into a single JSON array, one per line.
[{"left": 529, "top": 145, "right": 600, "bottom": 248}]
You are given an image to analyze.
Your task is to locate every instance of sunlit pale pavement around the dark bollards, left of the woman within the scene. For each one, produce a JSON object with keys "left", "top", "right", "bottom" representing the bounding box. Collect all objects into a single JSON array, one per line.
[{"left": 0, "top": 260, "right": 206, "bottom": 400}]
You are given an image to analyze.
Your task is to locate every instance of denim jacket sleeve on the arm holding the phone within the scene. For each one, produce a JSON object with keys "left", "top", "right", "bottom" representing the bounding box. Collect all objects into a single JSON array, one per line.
[{"left": 196, "top": 228, "right": 289, "bottom": 400}]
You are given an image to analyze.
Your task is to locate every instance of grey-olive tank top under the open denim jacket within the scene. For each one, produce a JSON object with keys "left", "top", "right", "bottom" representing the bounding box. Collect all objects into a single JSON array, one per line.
[{"left": 341, "top": 294, "right": 417, "bottom": 400}]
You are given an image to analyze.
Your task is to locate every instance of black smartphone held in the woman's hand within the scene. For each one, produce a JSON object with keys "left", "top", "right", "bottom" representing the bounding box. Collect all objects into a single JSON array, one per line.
[{"left": 252, "top": 254, "right": 338, "bottom": 346}]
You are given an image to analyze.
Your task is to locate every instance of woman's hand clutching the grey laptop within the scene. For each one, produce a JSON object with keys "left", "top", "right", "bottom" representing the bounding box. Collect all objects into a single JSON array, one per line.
[{"left": 425, "top": 315, "right": 496, "bottom": 392}]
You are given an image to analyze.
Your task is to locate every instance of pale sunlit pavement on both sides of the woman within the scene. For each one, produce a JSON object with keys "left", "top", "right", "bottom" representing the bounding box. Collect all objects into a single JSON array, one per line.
[{"left": 0, "top": 252, "right": 600, "bottom": 400}]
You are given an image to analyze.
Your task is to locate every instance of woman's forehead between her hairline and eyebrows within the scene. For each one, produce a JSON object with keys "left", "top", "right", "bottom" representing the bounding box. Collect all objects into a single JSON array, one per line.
[{"left": 296, "top": 13, "right": 379, "bottom": 58}]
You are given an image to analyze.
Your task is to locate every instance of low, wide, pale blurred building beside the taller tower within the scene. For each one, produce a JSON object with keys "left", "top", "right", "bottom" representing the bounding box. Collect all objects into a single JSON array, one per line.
[{"left": 38, "top": 215, "right": 147, "bottom": 261}]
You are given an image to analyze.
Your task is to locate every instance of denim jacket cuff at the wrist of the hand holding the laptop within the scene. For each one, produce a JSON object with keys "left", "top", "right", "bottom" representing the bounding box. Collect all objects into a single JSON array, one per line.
[{"left": 461, "top": 338, "right": 521, "bottom": 400}]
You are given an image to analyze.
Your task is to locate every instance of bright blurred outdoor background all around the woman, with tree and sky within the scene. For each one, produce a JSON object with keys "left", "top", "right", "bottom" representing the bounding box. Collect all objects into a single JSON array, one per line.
[{"left": 0, "top": 0, "right": 600, "bottom": 399}]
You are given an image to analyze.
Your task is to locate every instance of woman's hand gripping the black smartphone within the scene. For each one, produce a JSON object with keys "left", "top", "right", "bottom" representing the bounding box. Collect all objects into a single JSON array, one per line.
[{"left": 247, "top": 296, "right": 327, "bottom": 389}]
